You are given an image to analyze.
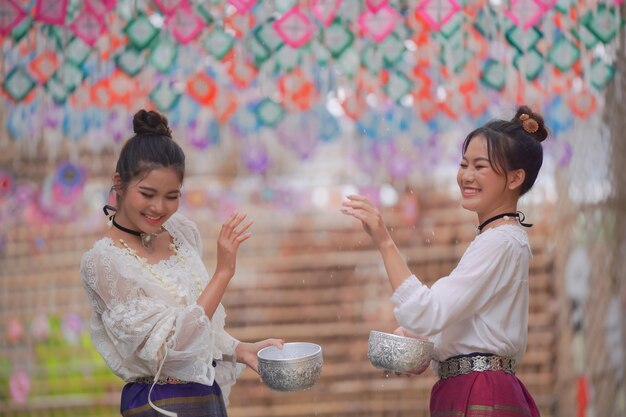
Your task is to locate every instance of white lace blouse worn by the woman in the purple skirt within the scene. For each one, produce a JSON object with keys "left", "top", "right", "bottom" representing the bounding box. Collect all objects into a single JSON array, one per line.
[{"left": 80, "top": 214, "right": 244, "bottom": 404}]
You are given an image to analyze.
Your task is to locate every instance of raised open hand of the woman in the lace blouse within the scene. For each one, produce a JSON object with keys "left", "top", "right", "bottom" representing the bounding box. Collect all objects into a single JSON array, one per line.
[{"left": 215, "top": 212, "right": 252, "bottom": 280}]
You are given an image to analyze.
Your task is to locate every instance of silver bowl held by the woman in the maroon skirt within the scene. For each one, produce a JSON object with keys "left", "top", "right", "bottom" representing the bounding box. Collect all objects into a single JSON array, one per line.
[{"left": 367, "top": 330, "right": 435, "bottom": 372}]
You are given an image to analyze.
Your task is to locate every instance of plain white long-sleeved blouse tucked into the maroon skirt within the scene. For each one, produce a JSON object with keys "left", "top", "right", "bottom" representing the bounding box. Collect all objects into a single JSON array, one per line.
[{"left": 391, "top": 225, "right": 532, "bottom": 361}]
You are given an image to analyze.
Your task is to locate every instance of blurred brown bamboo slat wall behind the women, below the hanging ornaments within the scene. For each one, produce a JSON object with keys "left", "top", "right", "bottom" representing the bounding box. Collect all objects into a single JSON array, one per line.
[{"left": 0, "top": 184, "right": 557, "bottom": 417}]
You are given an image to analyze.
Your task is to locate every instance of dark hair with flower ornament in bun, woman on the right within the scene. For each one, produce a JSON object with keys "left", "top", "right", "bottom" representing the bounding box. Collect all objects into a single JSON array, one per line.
[{"left": 462, "top": 105, "right": 548, "bottom": 196}]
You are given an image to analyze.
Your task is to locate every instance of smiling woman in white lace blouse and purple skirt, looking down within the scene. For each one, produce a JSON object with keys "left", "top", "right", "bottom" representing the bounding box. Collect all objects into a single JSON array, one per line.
[{"left": 80, "top": 110, "right": 283, "bottom": 417}]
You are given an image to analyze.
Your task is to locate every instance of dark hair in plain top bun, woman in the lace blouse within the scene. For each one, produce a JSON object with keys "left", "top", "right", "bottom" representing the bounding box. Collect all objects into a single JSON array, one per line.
[{"left": 115, "top": 109, "right": 185, "bottom": 189}]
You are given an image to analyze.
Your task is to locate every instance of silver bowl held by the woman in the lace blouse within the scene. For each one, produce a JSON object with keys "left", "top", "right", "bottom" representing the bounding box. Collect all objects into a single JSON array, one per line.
[{"left": 257, "top": 342, "right": 324, "bottom": 391}]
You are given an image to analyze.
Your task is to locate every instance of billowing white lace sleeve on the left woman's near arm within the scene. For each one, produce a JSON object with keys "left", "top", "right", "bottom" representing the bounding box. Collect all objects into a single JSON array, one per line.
[{"left": 81, "top": 245, "right": 223, "bottom": 385}]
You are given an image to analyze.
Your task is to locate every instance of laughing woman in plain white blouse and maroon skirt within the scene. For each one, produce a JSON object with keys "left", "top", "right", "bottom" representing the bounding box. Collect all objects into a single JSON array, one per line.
[{"left": 342, "top": 106, "right": 548, "bottom": 417}]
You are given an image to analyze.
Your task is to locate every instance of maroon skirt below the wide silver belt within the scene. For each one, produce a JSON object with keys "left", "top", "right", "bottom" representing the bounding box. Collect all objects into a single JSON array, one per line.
[{"left": 430, "top": 371, "right": 540, "bottom": 417}]
